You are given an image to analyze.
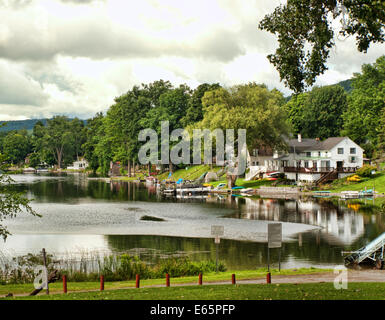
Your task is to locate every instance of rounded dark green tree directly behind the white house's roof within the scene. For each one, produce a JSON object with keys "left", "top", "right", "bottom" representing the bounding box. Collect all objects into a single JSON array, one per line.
[{"left": 286, "top": 85, "right": 348, "bottom": 139}]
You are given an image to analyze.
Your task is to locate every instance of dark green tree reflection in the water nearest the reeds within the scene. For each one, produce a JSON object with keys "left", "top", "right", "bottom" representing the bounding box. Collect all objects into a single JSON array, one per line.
[{"left": 106, "top": 233, "right": 343, "bottom": 269}]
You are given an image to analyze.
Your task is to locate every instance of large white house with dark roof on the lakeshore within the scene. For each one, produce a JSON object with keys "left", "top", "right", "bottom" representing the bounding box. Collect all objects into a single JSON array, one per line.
[{"left": 246, "top": 135, "right": 364, "bottom": 181}]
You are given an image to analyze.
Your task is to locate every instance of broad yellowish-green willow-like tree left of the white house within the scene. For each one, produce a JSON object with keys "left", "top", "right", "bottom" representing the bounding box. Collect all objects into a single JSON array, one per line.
[{"left": 194, "top": 83, "right": 289, "bottom": 185}]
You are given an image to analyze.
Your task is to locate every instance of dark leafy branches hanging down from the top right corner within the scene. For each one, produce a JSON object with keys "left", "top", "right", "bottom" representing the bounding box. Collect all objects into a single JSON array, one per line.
[{"left": 259, "top": 0, "right": 385, "bottom": 93}]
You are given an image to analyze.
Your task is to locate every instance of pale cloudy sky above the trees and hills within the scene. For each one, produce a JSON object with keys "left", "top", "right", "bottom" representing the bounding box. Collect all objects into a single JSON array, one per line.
[{"left": 0, "top": 0, "right": 385, "bottom": 120}]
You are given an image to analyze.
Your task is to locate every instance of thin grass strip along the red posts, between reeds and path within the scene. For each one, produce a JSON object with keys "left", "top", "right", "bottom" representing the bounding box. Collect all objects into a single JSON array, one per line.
[{"left": 0, "top": 268, "right": 332, "bottom": 296}]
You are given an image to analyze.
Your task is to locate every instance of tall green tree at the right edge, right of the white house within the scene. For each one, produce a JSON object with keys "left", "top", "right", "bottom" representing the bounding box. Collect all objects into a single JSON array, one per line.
[{"left": 343, "top": 56, "right": 385, "bottom": 156}]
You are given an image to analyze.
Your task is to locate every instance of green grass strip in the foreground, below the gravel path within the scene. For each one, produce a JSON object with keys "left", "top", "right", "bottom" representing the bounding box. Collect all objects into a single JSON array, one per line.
[{"left": 8, "top": 283, "right": 385, "bottom": 300}]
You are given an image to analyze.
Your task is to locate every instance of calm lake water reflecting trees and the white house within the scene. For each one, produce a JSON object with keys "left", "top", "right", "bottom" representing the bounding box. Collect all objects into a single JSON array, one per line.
[{"left": 0, "top": 174, "right": 385, "bottom": 269}]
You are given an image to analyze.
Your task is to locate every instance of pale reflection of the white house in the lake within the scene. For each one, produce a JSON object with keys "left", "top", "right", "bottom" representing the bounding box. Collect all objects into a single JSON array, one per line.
[{"left": 241, "top": 199, "right": 365, "bottom": 245}]
